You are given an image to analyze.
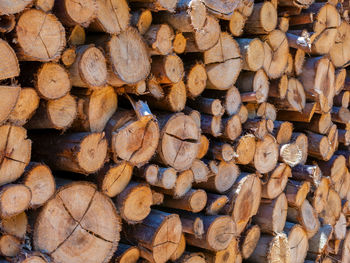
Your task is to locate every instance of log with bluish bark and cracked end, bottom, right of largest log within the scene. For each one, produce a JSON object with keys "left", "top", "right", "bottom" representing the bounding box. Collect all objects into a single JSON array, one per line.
[{"left": 123, "top": 210, "right": 182, "bottom": 263}]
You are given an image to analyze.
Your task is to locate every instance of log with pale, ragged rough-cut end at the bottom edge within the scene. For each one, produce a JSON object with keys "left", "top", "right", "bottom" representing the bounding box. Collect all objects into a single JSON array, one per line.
[{"left": 249, "top": 233, "right": 291, "bottom": 263}]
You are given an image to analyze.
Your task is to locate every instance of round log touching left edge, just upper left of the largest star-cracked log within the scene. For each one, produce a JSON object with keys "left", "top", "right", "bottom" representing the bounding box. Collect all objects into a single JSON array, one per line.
[{"left": 0, "top": 184, "right": 32, "bottom": 219}]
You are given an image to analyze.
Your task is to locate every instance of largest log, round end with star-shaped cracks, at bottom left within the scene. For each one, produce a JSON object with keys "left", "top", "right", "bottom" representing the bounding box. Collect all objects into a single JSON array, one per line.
[{"left": 33, "top": 182, "right": 121, "bottom": 262}]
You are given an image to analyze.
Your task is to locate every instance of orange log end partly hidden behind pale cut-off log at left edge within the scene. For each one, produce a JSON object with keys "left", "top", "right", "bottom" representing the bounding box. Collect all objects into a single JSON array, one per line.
[{"left": 8, "top": 88, "right": 40, "bottom": 126}]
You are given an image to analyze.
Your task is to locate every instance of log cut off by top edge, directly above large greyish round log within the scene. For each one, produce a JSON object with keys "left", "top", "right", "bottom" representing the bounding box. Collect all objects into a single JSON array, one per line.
[{"left": 90, "top": 0, "right": 130, "bottom": 34}]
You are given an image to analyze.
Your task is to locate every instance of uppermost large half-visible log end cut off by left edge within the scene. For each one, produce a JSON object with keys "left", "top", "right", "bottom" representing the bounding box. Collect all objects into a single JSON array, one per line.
[{"left": 0, "top": 38, "right": 19, "bottom": 80}]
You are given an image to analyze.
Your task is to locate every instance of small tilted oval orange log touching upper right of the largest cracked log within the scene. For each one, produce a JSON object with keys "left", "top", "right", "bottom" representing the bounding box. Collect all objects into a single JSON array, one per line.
[{"left": 94, "top": 161, "right": 133, "bottom": 197}]
